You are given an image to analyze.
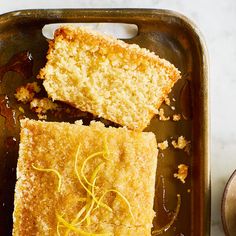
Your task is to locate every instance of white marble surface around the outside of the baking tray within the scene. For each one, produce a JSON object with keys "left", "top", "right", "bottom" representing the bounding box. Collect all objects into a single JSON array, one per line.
[{"left": 0, "top": 0, "right": 236, "bottom": 236}]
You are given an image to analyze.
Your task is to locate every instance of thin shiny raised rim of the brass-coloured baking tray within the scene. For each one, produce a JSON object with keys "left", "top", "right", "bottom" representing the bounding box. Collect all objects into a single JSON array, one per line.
[{"left": 0, "top": 8, "right": 211, "bottom": 235}]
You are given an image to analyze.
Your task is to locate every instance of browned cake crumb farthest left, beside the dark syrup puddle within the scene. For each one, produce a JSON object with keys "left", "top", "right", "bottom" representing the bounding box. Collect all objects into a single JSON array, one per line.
[{"left": 15, "top": 82, "right": 41, "bottom": 103}]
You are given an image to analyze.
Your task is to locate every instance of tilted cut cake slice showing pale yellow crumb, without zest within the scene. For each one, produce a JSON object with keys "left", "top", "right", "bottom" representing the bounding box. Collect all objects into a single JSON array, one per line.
[{"left": 38, "top": 26, "right": 180, "bottom": 131}]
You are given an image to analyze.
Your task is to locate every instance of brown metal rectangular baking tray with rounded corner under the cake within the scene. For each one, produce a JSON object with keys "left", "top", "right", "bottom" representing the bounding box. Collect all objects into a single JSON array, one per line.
[{"left": 0, "top": 9, "right": 210, "bottom": 236}]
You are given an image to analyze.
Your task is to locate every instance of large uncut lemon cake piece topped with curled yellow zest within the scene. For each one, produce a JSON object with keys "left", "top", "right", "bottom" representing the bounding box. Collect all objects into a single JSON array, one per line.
[{"left": 13, "top": 119, "right": 157, "bottom": 236}]
